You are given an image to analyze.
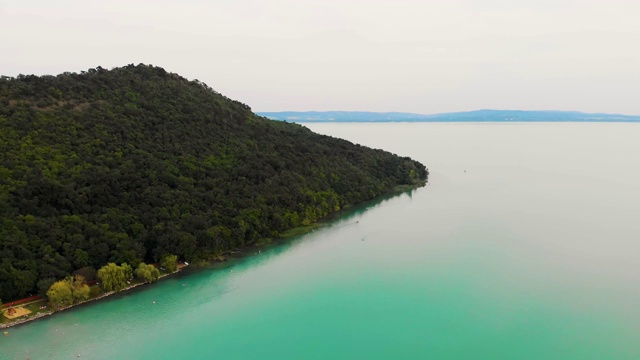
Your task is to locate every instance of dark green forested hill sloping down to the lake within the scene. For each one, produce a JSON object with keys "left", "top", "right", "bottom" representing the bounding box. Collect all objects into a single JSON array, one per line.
[{"left": 0, "top": 65, "right": 428, "bottom": 301}]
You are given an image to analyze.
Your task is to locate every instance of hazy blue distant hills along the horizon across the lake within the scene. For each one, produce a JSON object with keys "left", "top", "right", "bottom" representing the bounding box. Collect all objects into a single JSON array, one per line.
[{"left": 257, "top": 110, "right": 640, "bottom": 122}]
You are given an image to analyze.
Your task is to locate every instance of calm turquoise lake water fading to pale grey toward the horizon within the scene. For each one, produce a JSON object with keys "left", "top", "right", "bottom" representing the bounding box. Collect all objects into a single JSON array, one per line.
[{"left": 0, "top": 123, "right": 640, "bottom": 359}]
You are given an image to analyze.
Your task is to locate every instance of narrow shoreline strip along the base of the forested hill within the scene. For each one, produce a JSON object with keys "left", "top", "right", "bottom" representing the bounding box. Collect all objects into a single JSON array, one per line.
[{"left": 0, "top": 181, "right": 427, "bottom": 330}]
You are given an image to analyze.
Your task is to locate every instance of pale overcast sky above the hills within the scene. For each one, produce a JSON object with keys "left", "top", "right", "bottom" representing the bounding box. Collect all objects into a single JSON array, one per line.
[{"left": 0, "top": 0, "right": 640, "bottom": 115}]
